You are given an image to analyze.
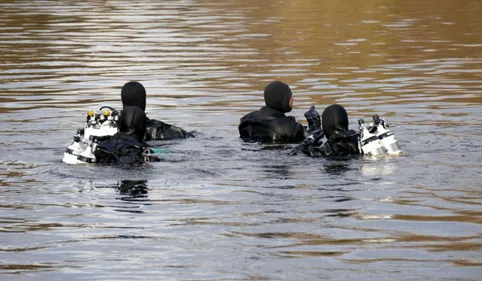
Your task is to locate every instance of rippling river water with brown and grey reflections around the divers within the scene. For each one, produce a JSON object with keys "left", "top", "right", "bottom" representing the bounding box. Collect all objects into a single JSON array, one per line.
[{"left": 0, "top": 0, "right": 482, "bottom": 280}]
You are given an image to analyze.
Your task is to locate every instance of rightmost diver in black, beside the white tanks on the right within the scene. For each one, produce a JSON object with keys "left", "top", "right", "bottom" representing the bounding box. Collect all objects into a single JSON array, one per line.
[{"left": 290, "top": 104, "right": 361, "bottom": 156}]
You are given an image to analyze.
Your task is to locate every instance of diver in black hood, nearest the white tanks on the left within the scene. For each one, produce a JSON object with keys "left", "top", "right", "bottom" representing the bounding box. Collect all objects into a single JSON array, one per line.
[{"left": 94, "top": 106, "right": 156, "bottom": 165}]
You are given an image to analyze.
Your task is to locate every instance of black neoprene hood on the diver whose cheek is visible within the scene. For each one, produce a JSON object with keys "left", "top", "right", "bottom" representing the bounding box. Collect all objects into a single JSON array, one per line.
[{"left": 264, "top": 81, "right": 293, "bottom": 112}]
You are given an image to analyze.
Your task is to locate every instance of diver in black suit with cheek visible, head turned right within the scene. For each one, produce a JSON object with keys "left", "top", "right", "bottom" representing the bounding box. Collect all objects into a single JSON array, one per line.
[{"left": 238, "top": 81, "right": 320, "bottom": 143}]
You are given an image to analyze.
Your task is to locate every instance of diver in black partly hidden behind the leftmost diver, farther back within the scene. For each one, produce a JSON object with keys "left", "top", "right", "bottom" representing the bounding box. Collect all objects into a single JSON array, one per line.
[{"left": 121, "top": 81, "right": 194, "bottom": 141}]
